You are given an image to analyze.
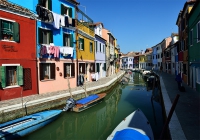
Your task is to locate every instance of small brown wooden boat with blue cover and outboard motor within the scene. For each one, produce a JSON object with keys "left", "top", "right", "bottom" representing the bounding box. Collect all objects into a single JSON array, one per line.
[{"left": 63, "top": 93, "right": 106, "bottom": 112}]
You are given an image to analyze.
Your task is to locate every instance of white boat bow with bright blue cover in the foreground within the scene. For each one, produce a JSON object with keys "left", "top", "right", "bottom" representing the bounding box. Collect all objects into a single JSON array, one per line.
[{"left": 107, "top": 109, "right": 154, "bottom": 140}]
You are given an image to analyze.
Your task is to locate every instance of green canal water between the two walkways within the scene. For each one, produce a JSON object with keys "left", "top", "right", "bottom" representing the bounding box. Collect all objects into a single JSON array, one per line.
[{"left": 22, "top": 73, "right": 164, "bottom": 140}]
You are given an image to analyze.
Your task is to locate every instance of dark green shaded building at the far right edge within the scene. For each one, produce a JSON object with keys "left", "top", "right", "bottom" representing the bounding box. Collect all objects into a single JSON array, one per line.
[{"left": 188, "top": 1, "right": 200, "bottom": 92}]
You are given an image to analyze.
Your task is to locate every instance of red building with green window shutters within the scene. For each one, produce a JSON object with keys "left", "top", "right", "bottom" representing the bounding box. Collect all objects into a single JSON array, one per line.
[{"left": 0, "top": 2, "right": 38, "bottom": 101}]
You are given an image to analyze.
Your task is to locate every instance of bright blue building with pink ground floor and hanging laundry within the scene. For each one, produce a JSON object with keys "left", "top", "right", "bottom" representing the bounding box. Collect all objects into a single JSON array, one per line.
[{"left": 10, "top": 0, "right": 79, "bottom": 94}]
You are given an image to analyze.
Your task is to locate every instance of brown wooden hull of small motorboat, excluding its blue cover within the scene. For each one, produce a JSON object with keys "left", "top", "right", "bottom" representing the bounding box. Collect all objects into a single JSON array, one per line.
[{"left": 72, "top": 93, "right": 106, "bottom": 112}]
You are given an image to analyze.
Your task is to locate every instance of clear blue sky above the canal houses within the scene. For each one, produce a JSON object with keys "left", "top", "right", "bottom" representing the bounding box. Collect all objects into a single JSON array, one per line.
[{"left": 77, "top": 0, "right": 186, "bottom": 53}]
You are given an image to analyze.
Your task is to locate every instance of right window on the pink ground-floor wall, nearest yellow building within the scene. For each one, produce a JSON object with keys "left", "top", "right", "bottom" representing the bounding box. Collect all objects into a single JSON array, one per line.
[{"left": 63, "top": 63, "right": 75, "bottom": 78}]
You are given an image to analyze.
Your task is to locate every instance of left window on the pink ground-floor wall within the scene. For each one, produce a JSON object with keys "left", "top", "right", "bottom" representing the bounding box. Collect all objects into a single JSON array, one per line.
[{"left": 40, "top": 63, "right": 55, "bottom": 80}]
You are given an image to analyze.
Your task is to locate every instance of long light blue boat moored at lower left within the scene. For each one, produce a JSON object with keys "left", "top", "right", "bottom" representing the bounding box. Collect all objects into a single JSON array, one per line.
[{"left": 0, "top": 110, "right": 62, "bottom": 140}]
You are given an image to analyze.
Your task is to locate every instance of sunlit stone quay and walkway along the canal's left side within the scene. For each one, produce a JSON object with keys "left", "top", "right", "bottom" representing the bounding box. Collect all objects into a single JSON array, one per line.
[{"left": 0, "top": 71, "right": 125, "bottom": 123}]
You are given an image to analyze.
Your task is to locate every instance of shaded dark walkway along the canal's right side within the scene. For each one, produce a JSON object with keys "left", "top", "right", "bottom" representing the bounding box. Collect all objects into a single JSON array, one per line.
[{"left": 157, "top": 72, "right": 200, "bottom": 140}]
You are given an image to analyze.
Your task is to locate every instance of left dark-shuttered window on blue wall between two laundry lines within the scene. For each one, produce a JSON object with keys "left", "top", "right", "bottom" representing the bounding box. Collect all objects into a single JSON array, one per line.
[{"left": 38, "top": 28, "right": 53, "bottom": 44}]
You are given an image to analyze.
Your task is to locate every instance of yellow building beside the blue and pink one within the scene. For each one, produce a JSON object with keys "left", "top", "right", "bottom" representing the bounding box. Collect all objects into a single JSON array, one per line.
[{"left": 76, "top": 10, "right": 95, "bottom": 82}]
